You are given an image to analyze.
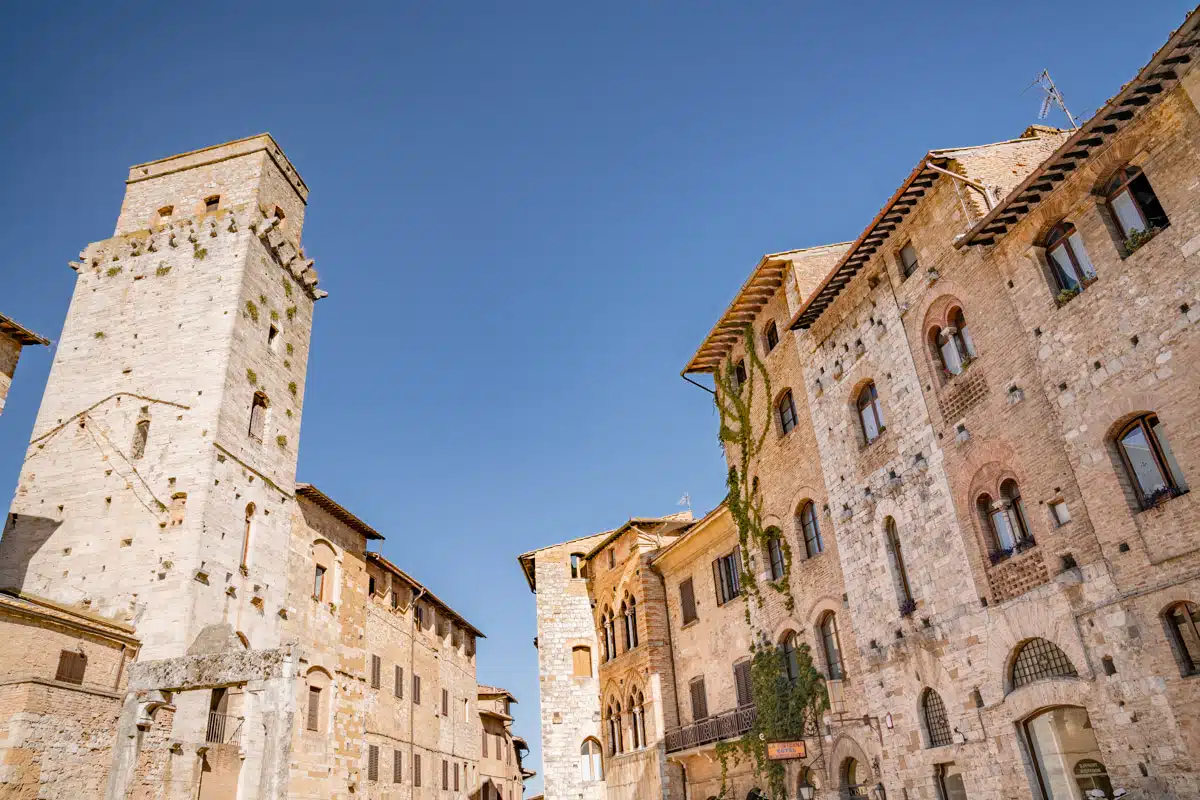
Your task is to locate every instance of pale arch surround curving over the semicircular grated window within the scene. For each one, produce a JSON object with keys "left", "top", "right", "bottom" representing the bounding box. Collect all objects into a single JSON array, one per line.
[{"left": 983, "top": 600, "right": 1093, "bottom": 700}]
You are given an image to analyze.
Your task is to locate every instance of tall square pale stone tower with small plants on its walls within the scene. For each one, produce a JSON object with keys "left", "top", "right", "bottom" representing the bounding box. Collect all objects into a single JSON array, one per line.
[{"left": 0, "top": 134, "right": 324, "bottom": 661}]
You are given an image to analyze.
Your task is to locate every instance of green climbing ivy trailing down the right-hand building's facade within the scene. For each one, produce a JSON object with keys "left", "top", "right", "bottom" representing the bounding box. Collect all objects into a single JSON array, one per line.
[{"left": 715, "top": 325, "right": 829, "bottom": 800}]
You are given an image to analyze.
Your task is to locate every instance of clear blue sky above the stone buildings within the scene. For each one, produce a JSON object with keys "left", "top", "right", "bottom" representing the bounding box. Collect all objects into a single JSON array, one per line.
[{"left": 0, "top": 0, "right": 1189, "bottom": 793}]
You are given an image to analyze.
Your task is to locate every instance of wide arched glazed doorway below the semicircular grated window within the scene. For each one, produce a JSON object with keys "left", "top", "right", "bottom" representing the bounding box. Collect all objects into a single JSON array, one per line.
[{"left": 1024, "top": 705, "right": 1112, "bottom": 800}]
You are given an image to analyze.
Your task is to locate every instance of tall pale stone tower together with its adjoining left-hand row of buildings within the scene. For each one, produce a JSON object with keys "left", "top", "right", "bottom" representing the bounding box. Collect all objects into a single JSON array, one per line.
[{"left": 0, "top": 134, "right": 513, "bottom": 800}]
